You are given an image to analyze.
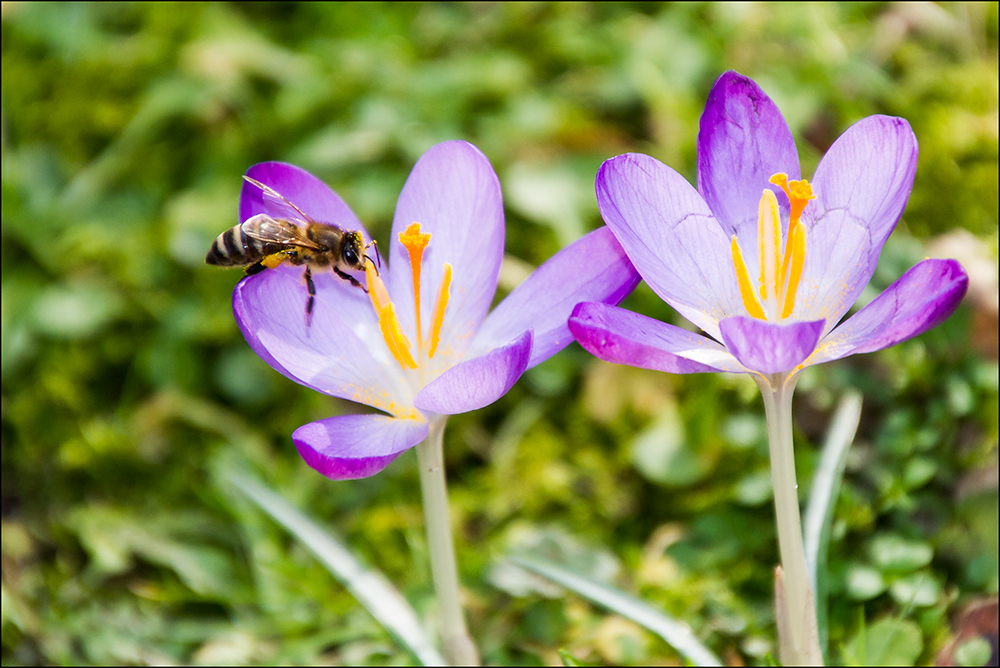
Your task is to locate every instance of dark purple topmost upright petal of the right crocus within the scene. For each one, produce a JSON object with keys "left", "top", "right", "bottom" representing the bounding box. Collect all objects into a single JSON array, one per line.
[{"left": 698, "top": 71, "right": 799, "bottom": 245}]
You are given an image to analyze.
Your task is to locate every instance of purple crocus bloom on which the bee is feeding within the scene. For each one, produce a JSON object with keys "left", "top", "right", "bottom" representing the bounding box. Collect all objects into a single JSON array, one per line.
[{"left": 233, "top": 141, "right": 639, "bottom": 479}]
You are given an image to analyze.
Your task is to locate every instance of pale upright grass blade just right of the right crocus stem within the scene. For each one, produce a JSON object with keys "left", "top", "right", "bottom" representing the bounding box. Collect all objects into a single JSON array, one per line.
[{"left": 802, "top": 391, "right": 861, "bottom": 656}]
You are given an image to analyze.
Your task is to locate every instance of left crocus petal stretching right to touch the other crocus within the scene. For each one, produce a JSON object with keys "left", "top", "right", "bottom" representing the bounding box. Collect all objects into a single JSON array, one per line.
[{"left": 472, "top": 227, "right": 639, "bottom": 368}]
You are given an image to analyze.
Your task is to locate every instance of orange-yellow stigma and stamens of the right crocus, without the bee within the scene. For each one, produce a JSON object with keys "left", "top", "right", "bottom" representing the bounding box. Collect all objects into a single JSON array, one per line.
[{"left": 732, "top": 174, "right": 816, "bottom": 320}]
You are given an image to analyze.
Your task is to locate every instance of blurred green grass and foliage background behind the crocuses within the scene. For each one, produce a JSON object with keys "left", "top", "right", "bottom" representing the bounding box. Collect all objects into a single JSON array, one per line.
[{"left": 2, "top": 2, "right": 998, "bottom": 665}]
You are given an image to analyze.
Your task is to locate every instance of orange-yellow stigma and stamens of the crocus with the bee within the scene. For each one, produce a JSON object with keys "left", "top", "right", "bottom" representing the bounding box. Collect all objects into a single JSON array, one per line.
[{"left": 365, "top": 223, "right": 451, "bottom": 369}]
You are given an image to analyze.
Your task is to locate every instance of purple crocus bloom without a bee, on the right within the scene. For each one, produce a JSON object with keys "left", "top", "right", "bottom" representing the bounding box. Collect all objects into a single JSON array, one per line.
[{"left": 570, "top": 72, "right": 968, "bottom": 385}]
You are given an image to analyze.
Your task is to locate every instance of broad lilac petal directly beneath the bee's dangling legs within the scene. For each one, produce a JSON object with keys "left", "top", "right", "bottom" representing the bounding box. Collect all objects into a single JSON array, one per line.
[{"left": 233, "top": 266, "right": 414, "bottom": 415}]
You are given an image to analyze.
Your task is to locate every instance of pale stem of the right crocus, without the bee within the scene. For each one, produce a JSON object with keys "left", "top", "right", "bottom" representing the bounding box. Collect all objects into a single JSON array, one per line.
[{"left": 757, "top": 374, "right": 823, "bottom": 666}]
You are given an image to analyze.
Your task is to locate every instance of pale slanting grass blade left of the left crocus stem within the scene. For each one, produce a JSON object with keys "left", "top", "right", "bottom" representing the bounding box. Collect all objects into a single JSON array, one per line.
[{"left": 226, "top": 471, "right": 445, "bottom": 666}]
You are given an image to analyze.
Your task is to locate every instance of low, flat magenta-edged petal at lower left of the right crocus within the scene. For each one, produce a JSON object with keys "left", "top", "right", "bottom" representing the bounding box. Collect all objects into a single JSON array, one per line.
[{"left": 569, "top": 302, "right": 747, "bottom": 373}]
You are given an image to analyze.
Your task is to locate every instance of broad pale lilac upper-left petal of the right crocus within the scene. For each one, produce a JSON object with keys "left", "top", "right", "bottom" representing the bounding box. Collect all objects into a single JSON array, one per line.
[{"left": 597, "top": 153, "right": 746, "bottom": 339}]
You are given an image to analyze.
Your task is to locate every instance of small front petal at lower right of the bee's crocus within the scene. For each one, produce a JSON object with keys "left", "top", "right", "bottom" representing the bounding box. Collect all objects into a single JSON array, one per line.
[{"left": 413, "top": 329, "right": 532, "bottom": 415}]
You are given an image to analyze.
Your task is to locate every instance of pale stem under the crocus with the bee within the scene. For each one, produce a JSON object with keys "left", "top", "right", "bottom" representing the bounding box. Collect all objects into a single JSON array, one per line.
[{"left": 417, "top": 418, "right": 479, "bottom": 666}]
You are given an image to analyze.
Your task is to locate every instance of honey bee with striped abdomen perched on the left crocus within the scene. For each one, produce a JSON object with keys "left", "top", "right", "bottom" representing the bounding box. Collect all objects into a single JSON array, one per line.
[{"left": 205, "top": 176, "right": 378, "bottom": 327}]
